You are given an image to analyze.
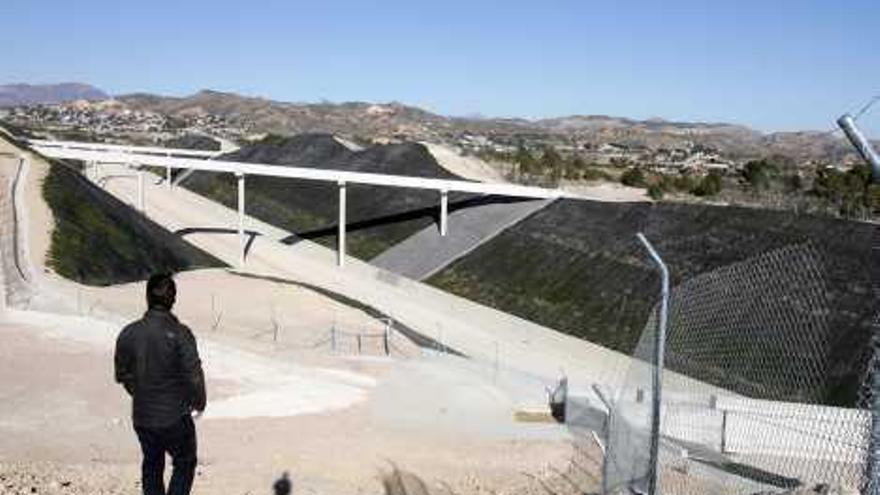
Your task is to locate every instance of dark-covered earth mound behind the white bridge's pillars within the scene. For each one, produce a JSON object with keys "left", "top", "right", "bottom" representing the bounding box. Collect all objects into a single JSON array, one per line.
[{"left": 184, "top": 134, "right": 467, "bottom": 259}]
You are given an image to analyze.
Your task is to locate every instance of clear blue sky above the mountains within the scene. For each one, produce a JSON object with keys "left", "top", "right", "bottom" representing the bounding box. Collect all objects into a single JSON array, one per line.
[{"left": 0, "top": 0, "right": 880, "bottom": 136}]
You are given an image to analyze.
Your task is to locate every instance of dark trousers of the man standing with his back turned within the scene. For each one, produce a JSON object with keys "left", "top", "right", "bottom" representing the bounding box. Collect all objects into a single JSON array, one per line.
[{"left": 135, "top": 415, "right": 196, "bottom": 495}]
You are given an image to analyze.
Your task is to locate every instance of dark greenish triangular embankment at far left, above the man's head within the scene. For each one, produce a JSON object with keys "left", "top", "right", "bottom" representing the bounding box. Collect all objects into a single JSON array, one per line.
[{"left": 43, "top": 163, "right": 225, "bottom": 285}]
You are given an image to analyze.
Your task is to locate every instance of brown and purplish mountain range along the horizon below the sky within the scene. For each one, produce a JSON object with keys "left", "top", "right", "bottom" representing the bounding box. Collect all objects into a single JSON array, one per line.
[{"left": 0, "top": 84, "right": 868, "bottom": 162}]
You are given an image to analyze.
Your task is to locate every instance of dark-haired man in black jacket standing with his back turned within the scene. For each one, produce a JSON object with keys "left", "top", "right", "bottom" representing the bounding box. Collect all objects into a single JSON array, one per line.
[{"left": 115, "top": 274, "right": 205, "bottom": 495}]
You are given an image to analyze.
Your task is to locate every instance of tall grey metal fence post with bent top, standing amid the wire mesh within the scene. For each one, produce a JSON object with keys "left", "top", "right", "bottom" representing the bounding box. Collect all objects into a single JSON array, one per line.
[{"left": 636, "top": 232, "right": 669, "bottom": 495}]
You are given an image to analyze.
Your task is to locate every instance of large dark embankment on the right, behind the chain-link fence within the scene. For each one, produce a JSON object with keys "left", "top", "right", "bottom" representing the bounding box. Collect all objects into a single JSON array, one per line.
[{"left": 429, "top": 200, "right": 877, "bottom": 404}]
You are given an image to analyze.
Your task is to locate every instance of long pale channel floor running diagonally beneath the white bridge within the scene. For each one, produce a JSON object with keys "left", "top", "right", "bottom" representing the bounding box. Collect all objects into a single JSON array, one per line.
[{"left": 75, "top": 165, "right": 629, "bottom": 403}]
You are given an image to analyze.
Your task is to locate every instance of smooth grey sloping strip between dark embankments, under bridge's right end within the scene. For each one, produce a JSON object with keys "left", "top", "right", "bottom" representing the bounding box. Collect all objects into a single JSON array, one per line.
[{"left": 370, "top": 196, "right": 551, "bottom": 280}]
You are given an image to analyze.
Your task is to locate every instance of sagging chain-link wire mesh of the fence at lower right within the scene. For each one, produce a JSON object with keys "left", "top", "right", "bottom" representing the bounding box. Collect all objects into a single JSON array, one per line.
[{"left": 584, "top": 243, "right": 878, "bottom": 494}]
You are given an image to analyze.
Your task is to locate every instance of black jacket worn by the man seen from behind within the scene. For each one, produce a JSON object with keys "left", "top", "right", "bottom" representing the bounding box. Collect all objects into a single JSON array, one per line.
[{"left": 115, "top": 308, "right": 205, "bottom": 428}]
